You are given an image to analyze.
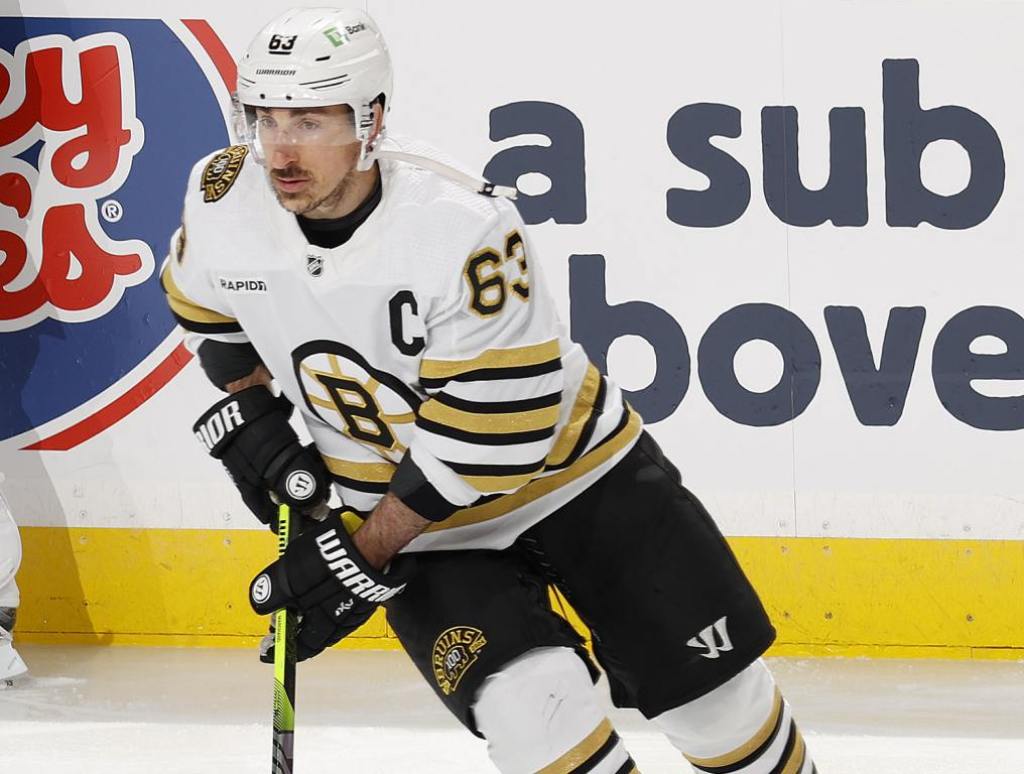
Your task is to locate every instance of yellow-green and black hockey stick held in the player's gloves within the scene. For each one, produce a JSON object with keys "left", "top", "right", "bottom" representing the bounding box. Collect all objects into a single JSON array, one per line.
[{"left": 270, "top": 505, "right": 298, "bottom": 774}]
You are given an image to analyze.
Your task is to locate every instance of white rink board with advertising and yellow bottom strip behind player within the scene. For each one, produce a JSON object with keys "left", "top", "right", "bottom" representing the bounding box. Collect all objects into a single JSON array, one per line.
[{"left": 0, "top": 0, "right": 1024, "bottom": 655}]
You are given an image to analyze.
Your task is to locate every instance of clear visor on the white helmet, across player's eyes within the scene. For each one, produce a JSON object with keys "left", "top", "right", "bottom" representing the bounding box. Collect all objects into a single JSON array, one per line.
[{"left": 238, "top": 104, "right": 359, "bottom": 160}]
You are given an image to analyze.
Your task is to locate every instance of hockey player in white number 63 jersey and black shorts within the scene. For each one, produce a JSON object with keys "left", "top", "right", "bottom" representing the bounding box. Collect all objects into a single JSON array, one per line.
[{"left": 162, "top": 8, "right": 814, "bottom": 774}]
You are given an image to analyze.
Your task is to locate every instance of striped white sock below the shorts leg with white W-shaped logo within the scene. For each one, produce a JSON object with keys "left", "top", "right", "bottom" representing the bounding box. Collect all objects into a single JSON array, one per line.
[{"left": 654, "top": 659, "right": 817, "bottom": 774}]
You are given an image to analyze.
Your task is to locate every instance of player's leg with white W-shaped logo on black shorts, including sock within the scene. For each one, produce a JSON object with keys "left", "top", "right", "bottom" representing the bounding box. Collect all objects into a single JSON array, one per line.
[{"left": 519, "top": 434, "right": 814, "bottom": 774}]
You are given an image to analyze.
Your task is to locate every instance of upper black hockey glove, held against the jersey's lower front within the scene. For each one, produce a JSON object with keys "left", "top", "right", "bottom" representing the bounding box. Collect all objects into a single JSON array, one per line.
[{"left": 193, "top": 385, "right": 330, "bottom": 531}]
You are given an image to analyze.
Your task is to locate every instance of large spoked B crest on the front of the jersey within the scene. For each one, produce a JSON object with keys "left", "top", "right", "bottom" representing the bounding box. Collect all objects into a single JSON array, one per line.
[{"left": 292, "top": 341, "right": 421, "bottom": 462}]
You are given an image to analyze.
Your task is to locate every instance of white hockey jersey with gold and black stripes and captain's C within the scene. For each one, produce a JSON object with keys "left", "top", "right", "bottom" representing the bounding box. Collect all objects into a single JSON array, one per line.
[{"left": 162, "top": 138, "right": 641, "bottom": 551}]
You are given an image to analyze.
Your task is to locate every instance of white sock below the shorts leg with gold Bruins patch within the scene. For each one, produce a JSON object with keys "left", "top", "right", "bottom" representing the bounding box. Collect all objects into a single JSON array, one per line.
[{"left": 473, "top": 648, "right": 637, "bottom": 774}]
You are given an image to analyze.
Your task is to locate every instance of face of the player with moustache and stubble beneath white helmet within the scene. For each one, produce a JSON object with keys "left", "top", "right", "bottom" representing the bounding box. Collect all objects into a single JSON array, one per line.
[{"left": 256, "top": 105, "right": 359, "bottom": 216}]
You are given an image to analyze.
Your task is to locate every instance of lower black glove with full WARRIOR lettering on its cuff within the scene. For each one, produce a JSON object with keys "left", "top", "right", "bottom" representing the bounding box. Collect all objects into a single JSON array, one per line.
[{"left": 249, "top": 509, "right": 415, "bottom": 662}]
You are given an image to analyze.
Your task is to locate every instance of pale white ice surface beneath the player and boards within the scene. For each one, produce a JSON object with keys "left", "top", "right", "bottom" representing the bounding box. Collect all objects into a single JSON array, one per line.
[{"left": 0, "top": 645, "right": 1024, "bottom": 774}]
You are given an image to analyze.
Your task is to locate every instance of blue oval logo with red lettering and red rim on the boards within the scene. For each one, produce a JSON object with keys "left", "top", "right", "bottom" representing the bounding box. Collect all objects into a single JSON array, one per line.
[{"left": 0, "top": 17, "right": 234, "bottom": 449}]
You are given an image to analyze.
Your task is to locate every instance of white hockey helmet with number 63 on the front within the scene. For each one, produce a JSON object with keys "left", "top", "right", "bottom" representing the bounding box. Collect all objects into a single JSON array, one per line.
[{"left": 236, "top": 8, "right": 392, "bottom": 170}]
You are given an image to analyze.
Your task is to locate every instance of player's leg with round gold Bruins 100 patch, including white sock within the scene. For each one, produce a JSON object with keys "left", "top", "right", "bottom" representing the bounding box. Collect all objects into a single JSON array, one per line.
[{"left": 387, "top": 551, "right": 635, "bottom": 774}]
